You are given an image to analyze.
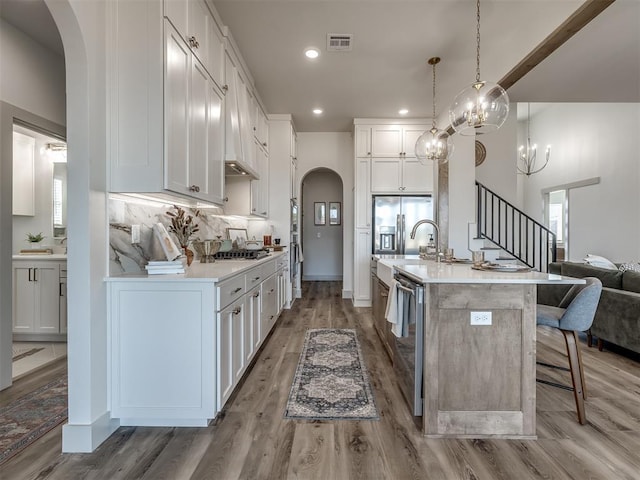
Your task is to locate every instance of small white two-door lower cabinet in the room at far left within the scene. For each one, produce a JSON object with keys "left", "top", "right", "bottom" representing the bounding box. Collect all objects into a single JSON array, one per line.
[{"left": 12, "top": 259, "right": 67, "bottom": 339}]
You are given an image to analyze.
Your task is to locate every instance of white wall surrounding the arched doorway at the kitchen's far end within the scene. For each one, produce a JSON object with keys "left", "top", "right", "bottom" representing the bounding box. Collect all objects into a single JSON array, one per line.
[{"left": 298, "top": 132, "right": 354, "bottom": 298}]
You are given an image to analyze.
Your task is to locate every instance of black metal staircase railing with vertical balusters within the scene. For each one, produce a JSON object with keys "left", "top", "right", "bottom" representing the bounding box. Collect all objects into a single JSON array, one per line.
[{"left": 476, "top": 182, "right": 557, "bottom": 272}]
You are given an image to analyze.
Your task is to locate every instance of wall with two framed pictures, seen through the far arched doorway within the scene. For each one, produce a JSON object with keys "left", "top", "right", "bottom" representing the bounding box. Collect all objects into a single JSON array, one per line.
[{"left": 302, "top": 169, "right": 344, "bottom": 280}]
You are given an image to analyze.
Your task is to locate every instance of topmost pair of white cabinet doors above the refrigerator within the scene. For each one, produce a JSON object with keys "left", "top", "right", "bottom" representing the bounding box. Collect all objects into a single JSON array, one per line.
[{"left": 368, "top": 125, "right": 428, "bottom": 158}]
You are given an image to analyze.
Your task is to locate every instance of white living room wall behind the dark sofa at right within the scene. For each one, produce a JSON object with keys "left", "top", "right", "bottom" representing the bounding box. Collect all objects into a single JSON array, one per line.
[{"left": 522, "top": 103, "right": 640, "bottom": 262}]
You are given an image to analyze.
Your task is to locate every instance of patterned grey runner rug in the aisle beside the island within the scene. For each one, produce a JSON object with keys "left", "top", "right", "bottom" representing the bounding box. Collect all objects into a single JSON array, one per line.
[{"left": 284, "top": 329, "right": 379, "bottom": 420}]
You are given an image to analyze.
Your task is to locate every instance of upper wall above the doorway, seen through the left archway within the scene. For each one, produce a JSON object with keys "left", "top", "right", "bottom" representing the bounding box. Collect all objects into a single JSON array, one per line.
[{"left": 0, "top": 18, "right": 66, "bottom": 125}]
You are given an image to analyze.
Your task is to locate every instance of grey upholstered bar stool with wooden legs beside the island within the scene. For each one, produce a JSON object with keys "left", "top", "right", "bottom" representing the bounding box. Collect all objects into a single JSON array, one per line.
[{"left": 536, "top": 277, "right": 602, "bottom": 425}]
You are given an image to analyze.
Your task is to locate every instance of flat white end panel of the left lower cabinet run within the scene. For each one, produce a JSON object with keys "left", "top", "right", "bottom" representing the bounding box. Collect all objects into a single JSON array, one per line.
[{"left": 108, "top": 279, "right": 217, "bottom": 426}]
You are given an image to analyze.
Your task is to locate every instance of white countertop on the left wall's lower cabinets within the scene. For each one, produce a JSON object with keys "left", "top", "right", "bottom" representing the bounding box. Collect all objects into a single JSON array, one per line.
[{"left": 105, "top": 252, "right": 285, "bottom": 282}]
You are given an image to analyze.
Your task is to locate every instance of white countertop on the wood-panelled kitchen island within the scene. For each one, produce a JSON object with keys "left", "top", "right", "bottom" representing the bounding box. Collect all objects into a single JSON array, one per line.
[{"left": 376, "top": 255, "right": 585, "bottom": 284}]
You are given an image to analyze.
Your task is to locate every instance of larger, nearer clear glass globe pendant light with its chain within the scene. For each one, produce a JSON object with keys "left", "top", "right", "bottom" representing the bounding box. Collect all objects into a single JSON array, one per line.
[{"left": 449, "top": 0, "right": 509, "bottom": 135}]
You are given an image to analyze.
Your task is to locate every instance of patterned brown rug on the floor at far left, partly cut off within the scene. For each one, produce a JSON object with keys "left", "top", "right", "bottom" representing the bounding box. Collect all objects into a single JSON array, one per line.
[{"left": 0, "top": 376, "right": 67, "bottom": 465}]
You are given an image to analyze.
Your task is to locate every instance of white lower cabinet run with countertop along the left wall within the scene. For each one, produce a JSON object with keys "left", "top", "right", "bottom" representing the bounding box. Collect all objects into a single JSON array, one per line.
[{"left": 106, "top": 252, "right": 288, "bottom": 426}]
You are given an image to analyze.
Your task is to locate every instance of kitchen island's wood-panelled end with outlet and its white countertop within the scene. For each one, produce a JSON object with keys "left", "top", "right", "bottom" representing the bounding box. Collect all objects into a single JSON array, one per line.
[{"left": 381, "top": 259, "right": 584, "bottom": 439}]
